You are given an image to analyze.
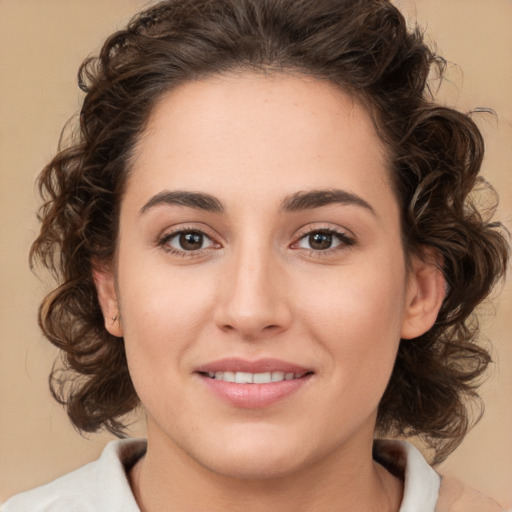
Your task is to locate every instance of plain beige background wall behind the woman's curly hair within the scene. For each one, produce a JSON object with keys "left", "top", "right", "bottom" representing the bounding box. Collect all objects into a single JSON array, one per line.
[{"left": 0, "top": 0, "right": 512, "bottom": 508}]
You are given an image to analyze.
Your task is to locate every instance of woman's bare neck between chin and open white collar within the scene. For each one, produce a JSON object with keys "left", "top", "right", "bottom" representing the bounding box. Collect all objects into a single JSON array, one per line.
[{"left": 129, "top": 430, "right": 402, "bottom": 512}]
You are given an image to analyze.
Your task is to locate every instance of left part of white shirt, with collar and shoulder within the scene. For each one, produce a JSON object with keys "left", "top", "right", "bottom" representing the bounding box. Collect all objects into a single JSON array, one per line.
[{"left": 1, "top": 440, "right": 146, "bottom": 512}]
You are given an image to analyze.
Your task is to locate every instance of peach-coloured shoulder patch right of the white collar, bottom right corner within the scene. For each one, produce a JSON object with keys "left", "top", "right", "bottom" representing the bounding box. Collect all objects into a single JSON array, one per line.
[{"left": 436, "top": 477, "right": 504, "bottom": 512}]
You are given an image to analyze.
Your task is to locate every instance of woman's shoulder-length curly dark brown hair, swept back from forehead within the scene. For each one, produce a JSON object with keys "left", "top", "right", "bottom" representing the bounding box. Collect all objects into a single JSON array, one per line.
[{"left": 31, "top": 0, "right": 509, "bottom": 462}]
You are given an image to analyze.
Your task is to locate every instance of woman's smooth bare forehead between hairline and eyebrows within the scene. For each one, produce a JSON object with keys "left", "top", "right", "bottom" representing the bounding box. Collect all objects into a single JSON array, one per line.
[{"left": 127, "top": 73, "right": 391, "bottom": 214}]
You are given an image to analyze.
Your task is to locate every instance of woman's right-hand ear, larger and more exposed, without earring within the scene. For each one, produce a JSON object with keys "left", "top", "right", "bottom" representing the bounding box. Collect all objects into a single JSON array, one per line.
[{"left": 401, "top": 248, "right": 446, "bottom": 339}]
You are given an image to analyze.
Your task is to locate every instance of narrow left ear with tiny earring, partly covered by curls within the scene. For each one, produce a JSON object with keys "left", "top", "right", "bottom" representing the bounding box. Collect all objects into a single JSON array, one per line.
[{"left": 92, "top": 263, "right": 123, "bottom": 338}]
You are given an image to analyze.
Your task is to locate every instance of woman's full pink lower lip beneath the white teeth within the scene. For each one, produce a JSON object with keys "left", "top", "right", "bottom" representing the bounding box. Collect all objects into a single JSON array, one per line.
[{"left": 200, "top": 374, "right": 312, "bottom": 409}]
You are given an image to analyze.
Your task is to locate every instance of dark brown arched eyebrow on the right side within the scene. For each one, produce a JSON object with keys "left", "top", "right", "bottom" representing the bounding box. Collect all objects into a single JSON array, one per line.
[{"left": 280, "top": 188, "right": 377, "bottom": 216}]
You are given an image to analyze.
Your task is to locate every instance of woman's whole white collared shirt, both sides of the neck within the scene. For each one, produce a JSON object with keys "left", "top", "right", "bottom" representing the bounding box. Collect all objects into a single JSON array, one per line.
[{"left": 1, "top": 439, "right": 441, "bottom": 512}]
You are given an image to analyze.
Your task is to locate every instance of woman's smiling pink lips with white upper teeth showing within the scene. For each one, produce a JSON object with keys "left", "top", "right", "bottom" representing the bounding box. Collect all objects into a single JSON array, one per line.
[{"left": 196, "top": 359, "right": 314, "bottom": 409}]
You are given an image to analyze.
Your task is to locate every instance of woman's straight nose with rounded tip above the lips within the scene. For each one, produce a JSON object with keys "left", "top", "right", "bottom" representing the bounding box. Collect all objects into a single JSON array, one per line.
[{"left": 214, "top": 246, "right": 292, "bottom": 341}]
